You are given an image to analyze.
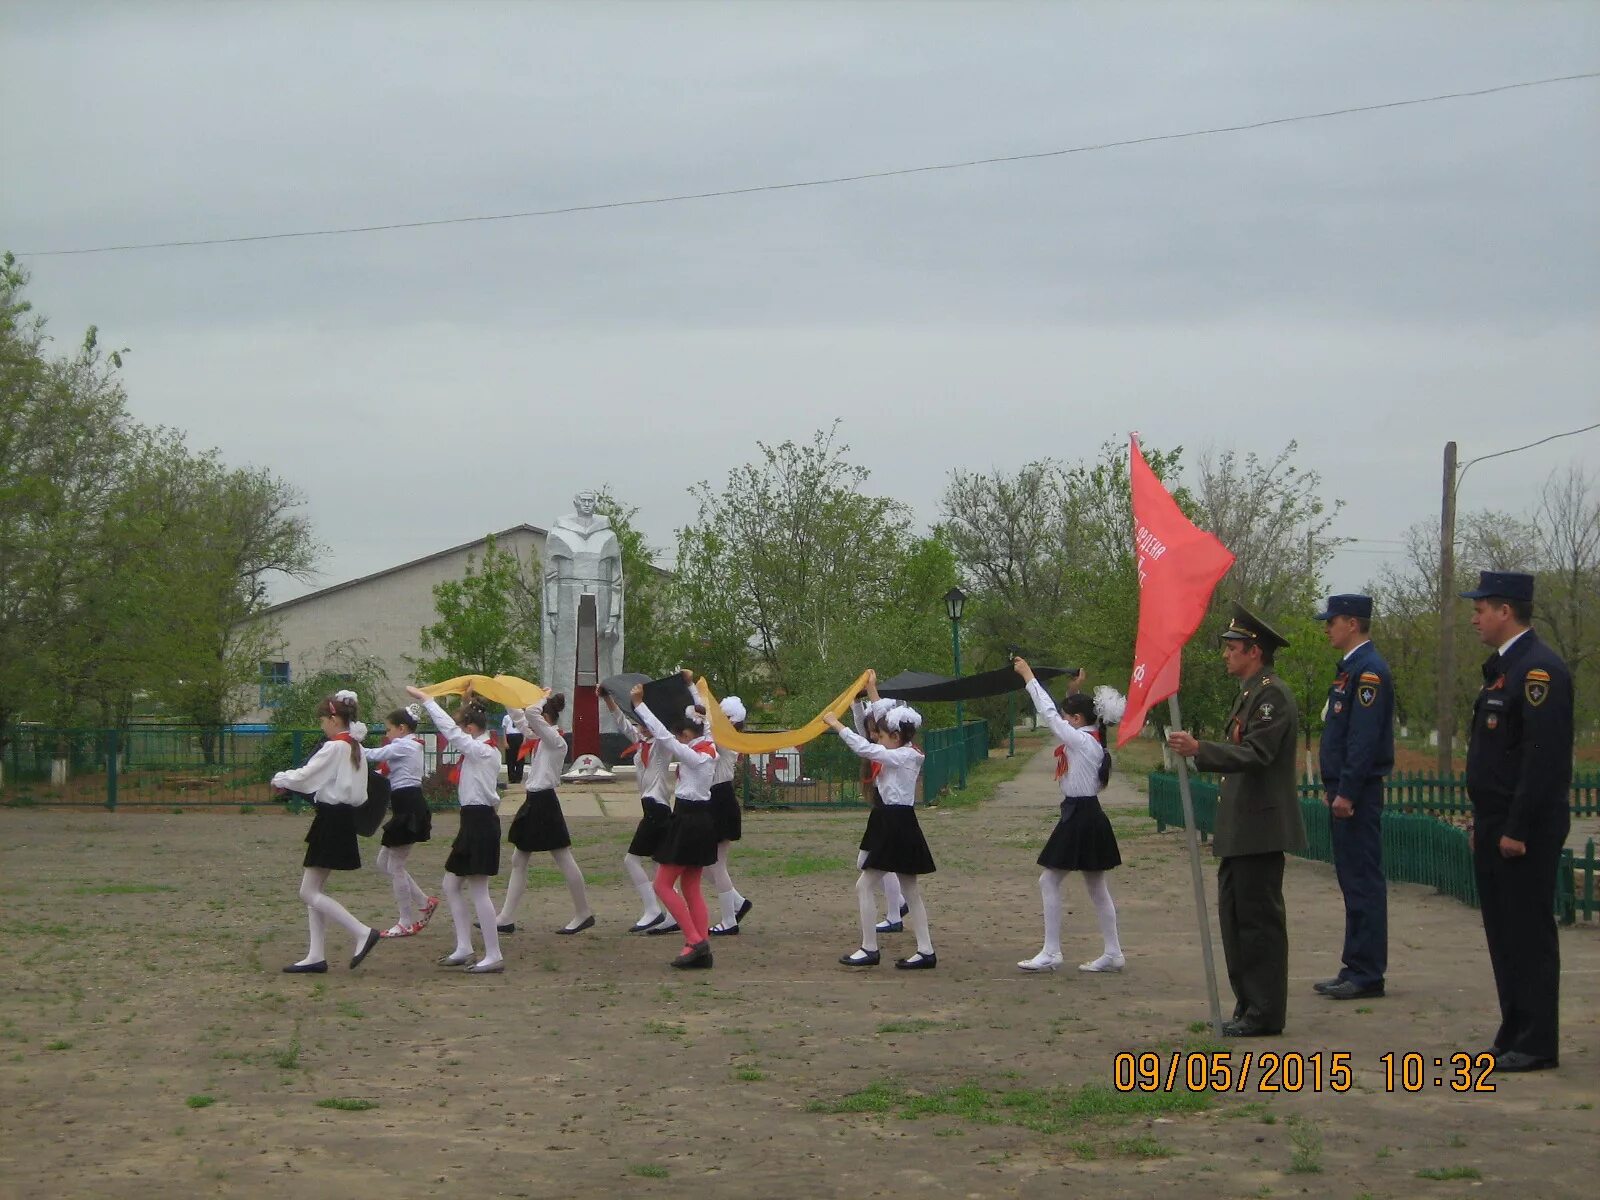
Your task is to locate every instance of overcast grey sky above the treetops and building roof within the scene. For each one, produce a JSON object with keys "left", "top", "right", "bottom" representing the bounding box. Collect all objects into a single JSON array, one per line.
[{"left": 0, "top": 0, "right": 1600, "bottom": 597}]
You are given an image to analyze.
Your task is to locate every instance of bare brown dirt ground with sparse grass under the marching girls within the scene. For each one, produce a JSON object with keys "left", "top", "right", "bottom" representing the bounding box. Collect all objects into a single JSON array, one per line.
[{"left": 0, "top": 755, "right": 1600, "bottom": 1200}]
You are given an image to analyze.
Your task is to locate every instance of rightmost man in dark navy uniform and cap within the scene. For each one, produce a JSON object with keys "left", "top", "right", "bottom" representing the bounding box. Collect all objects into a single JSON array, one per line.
[{"left": 1461, "top": 571, "right": 1573, "bottom": 1070}]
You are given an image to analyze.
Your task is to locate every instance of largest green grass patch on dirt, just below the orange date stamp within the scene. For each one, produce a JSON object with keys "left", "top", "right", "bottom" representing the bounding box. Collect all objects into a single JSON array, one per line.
[{"left": 806, "top": 1080, "right": 1211, "bottom": 1133}]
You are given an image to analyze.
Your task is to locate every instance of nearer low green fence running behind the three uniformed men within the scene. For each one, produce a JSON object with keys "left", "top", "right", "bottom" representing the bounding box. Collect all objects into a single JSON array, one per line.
[{"left": 1149, "top": 771, "right": 1600, "bottom": 925}]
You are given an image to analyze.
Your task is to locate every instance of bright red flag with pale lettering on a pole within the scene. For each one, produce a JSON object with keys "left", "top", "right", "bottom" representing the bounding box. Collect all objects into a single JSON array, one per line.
[{"left": 1117, "top": 435, "right": 1234, "bottom": 747}]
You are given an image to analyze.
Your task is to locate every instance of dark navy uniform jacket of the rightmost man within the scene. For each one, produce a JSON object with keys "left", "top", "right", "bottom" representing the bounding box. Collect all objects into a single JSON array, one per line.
[{"left": 1467, "top": 629, "right": 1573, "bottom": 842}]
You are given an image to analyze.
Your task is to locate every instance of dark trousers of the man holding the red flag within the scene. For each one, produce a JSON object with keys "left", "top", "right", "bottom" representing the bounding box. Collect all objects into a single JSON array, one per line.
[{"left": 1216, "top": 850, "right": 1290, "bottom": 1032}]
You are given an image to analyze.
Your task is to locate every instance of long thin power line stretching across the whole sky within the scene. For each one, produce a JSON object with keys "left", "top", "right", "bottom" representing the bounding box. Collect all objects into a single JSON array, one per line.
[{"left": 16, "top": 70, "right": 1600, "bottom": 258}]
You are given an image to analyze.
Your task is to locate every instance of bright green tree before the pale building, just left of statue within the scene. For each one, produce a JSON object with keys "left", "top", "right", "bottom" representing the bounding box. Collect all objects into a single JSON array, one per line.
[{"left": 413, "top": 534, "right": 541, "bottom": 680}]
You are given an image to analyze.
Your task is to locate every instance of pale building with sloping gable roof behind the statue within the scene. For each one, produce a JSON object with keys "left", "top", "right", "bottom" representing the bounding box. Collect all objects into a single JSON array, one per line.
[{"left": 243, "top": 525, "right": 546, "bottom": 723}]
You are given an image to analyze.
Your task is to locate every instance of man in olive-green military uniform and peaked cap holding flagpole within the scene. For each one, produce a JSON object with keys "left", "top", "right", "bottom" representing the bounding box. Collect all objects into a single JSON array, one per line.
[{"left": 1166, "top": 605, "right": 1306, "bottom": 1037}]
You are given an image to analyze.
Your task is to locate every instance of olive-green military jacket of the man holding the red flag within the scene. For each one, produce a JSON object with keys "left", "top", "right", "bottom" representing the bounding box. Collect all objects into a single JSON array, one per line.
[{"left": 1195, "top": 672, "right": 1306, "bottom": 858}]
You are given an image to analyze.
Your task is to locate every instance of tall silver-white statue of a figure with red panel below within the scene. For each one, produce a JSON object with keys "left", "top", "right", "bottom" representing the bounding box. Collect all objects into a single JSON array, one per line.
[{"left": 539, "top": 491, "right": 622, "bottom": 755}]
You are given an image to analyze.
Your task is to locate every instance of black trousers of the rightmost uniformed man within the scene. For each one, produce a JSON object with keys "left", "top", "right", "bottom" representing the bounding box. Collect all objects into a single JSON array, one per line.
[{"left": 1472, "top": 797, "right": 1571, "bottom": 1059}]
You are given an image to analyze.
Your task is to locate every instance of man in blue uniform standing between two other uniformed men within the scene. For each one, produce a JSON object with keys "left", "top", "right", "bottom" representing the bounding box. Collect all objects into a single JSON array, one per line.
[{"left": 1314, "top": 595, "right": 1395, "bottom": 1000}]
